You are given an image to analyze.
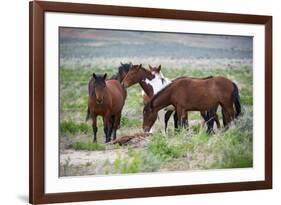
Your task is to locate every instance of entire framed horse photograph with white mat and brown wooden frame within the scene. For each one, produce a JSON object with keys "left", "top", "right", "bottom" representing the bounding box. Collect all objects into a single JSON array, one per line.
[{"left": 29, "top": 1, "right": 272, "bottom": 204}]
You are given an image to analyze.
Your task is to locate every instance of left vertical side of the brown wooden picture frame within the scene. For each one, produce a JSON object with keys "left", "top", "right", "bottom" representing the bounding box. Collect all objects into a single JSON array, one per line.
[{"left": 29, "top": 2, "right": 45, "bottom": 204}]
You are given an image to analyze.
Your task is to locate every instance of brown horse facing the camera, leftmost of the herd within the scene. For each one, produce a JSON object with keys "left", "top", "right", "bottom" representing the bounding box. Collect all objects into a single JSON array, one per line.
[{"left": 88, "top": 73, "right": 127, "bottom": 143}]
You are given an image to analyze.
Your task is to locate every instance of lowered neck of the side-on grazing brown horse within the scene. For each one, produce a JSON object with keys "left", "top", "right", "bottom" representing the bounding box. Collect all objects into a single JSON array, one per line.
[{"left": 152, "top": 88, "right": 172, "bottom": 112}]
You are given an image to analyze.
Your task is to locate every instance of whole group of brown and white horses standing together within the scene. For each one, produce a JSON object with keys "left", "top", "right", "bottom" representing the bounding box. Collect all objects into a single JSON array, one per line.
[{"left": 86, "top": 63, "right": 241, "bottom": 143}]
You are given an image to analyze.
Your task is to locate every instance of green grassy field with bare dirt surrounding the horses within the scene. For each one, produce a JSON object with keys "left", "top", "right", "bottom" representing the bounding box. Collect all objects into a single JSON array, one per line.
[{"left": 60, "top": 62, "right": 253, "bottom": 176}]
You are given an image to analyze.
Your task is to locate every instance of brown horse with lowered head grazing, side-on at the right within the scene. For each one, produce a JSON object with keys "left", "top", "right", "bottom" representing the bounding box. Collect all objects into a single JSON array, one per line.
[{"left": 143, "top": 77, "right": 241, "bottom": 132}]
